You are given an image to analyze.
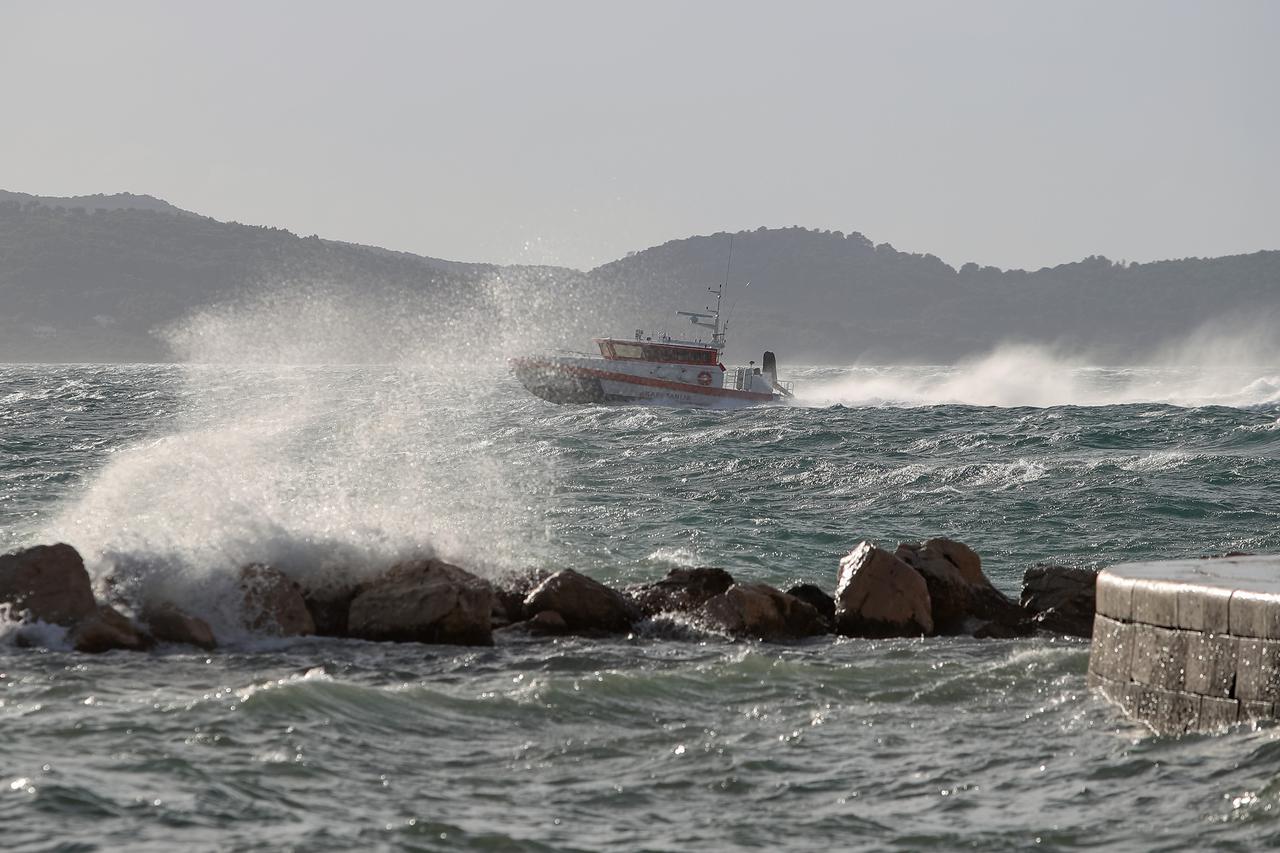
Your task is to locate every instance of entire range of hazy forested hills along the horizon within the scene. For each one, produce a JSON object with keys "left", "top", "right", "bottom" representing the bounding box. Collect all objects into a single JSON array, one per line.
[{"left": 0, "top": 192, "right": 1280, "bottom": 364}]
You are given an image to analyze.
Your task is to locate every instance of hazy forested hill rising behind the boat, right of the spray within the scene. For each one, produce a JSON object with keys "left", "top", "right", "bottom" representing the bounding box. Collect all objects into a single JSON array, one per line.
[{"left": 591, "top": 228, "right": 1280, "bottom": 362}]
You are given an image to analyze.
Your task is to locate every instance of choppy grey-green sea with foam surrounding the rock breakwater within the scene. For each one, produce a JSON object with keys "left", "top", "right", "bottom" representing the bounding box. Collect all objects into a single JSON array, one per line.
[{"left": 0, "top": 359, "right": 1280, "bottom": 850}]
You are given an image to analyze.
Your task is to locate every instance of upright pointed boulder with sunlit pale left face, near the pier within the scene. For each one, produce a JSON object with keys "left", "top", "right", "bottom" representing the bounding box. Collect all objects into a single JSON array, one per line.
[{"left": 836, "top": 542, "right": 933, "bottom": 637}]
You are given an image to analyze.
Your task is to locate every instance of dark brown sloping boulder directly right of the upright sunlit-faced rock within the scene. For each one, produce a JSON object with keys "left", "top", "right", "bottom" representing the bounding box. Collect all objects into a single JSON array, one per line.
[{"left": 895, "top": 538, "right": 1025, "bottom": 637}]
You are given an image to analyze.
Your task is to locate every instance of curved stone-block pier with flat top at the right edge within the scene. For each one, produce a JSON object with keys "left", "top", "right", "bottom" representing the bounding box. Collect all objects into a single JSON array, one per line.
[{"left": 1089, "top": 556, "right": 1280, "bottom": 734}]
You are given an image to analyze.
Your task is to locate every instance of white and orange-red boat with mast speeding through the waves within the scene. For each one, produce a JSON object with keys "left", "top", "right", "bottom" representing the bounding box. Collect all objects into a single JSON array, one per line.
[{"left": 509, "top": 277, "right": 792, "bottom": 407}]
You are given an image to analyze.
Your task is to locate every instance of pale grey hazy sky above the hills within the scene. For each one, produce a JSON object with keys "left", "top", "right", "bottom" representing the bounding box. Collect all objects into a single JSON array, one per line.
[{"left": 0, "top": 0, "right": 1280, "bottom": 268}]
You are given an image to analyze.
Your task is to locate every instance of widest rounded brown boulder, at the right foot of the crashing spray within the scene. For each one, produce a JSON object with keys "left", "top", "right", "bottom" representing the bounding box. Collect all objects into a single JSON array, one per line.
[{"left": 347, "top": 560, "right": 494, "bottom": 646}]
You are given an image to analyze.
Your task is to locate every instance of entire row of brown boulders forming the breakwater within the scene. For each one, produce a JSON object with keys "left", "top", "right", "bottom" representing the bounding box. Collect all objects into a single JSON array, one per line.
[{"left": 0, "top": 538, "right": 1093, "bottom": 652}]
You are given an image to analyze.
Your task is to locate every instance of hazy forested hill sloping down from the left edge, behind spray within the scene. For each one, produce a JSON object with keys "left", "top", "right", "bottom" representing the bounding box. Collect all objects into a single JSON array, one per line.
[{"left": 0, "top": 193, "right": 494, "bottom": 361}]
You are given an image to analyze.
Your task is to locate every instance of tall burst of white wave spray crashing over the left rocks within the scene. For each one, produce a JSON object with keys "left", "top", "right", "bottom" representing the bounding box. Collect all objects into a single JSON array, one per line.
[{"left": 40, "top": 268, "right": 599, "bottom": 634}]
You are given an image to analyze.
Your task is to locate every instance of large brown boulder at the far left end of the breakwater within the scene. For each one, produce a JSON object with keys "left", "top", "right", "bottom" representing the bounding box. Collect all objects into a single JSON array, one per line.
[{"left": 0, "top": 544, "right": 97, "bottom": 625}]
